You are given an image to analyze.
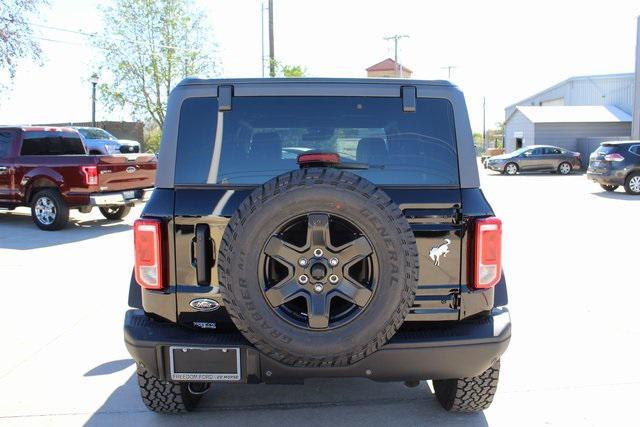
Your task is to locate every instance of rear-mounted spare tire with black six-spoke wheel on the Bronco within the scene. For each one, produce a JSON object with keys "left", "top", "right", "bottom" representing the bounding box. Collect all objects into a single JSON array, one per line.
[{"left": 218, "top": 168, "right": 418, "bottom": 367}]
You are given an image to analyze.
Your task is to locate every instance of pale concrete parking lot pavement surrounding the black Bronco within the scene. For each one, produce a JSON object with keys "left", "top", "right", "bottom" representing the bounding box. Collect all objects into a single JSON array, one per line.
[{"left": 0, "top": 171, "right": 640, "bottom": 426}]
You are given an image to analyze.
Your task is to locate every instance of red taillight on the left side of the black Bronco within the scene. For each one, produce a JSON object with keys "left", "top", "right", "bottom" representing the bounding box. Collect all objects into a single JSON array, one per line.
[{"left": 133, "top": 219, "right": 164, "bottom": 289}]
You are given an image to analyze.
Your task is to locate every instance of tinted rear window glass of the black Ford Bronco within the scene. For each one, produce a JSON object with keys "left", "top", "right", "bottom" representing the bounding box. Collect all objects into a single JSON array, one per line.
[{"left": 175, "top": 97, "right": 459, "bottom": 185}]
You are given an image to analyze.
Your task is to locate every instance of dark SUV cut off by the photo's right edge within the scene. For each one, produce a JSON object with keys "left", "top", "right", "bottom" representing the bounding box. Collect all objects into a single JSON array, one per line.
[{"left": 587, "top": 141, "right": 640, "bottom": 195}]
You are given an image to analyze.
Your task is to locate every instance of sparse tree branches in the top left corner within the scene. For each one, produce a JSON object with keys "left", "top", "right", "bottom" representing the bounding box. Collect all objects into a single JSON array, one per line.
[{"left": 0, "top": 0, "right": 47, "bottom": 88}]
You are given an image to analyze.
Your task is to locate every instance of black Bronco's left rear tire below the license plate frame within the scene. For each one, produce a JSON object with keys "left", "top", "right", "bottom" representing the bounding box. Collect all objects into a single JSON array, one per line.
[{"left": 137, "top": 365, "right": 203, "bottom": 414}]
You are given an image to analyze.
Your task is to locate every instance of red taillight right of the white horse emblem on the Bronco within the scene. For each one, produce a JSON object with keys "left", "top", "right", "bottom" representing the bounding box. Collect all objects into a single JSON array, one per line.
[{"left": 472, "top": 217, "right": 502, "bottom": 289}]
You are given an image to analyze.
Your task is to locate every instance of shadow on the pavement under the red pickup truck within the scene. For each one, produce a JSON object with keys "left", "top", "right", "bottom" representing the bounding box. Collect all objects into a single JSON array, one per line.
[{"left": 0, "top": 211, "right": 131, "bottom": 250}]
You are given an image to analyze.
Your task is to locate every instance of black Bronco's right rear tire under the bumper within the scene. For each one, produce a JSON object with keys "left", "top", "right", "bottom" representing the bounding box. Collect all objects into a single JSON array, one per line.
[{"left": 433, "top": 360, "right": 500, "bottom": 412}]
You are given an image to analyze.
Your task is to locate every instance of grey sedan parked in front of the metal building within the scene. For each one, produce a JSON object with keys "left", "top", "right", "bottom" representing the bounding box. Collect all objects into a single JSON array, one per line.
[{"left": 485, "top": 145, "right": 582, "bottom": 175}]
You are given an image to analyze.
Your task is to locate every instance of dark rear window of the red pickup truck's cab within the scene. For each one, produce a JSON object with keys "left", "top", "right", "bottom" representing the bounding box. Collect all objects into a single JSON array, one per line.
[{"left": 20, "top": 132, "right": 86, "bottom": 156}]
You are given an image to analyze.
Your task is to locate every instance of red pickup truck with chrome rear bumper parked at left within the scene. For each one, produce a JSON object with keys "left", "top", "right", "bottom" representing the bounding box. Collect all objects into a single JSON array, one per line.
[{"left": 0, "top": 126, "right": 156, "bottom": 230}]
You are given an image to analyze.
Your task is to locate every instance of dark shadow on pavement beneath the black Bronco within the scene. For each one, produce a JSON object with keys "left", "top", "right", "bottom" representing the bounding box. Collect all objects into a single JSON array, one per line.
[{"left": 86, "top": 372, "right": 488, "bottom": 427}]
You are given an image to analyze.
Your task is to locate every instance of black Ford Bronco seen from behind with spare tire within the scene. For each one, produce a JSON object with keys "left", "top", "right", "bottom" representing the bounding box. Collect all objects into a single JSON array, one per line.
[{"left": 124, "top": 79, "right": 511, "bottom": 413}]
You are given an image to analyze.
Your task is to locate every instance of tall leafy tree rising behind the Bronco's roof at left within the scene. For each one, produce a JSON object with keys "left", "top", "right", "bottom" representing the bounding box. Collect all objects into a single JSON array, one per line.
[{"left": 95, "top": 0, "right": 218, "bottom": 128}]
